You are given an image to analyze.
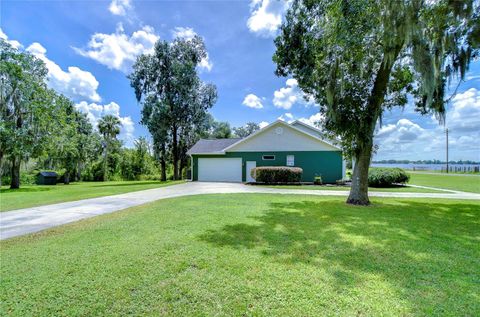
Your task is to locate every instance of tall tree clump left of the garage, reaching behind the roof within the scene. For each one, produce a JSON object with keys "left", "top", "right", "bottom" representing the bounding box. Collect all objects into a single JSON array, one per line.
[{"left": 128, "top": 36, "right": 259, "bottom": 180}]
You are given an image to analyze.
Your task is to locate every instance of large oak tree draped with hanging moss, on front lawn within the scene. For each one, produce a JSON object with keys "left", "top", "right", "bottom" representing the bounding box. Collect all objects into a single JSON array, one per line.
[{"left": 273, "top": 0, "right": 480, "bottom": 205}]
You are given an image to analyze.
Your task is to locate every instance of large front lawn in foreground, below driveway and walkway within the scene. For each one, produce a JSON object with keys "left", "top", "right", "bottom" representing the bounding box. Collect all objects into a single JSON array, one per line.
[{"left": 0, "top": 194, "right": 480, "bottom": 316}]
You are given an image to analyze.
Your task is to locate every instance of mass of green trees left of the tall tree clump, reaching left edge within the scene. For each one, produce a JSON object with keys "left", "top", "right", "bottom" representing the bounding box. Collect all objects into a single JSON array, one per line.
[{"left": 0, "top": 40, "right": 161, "bottom": 189}]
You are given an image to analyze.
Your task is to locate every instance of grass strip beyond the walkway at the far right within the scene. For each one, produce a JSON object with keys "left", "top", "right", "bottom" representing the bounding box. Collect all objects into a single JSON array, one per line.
[{"left": 409, "top": 172, "right": 480, "bottom": 193}]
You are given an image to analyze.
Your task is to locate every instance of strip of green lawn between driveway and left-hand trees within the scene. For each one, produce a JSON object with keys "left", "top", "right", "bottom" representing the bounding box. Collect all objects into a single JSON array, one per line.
[{"left": 0, "top": 181, "right": 182, "bottom": 211}]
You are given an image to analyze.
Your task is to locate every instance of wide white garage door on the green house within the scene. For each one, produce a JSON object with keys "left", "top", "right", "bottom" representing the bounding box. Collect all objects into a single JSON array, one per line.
[{"left": 198, "top": 158, "right": 242, "bottom": 182}]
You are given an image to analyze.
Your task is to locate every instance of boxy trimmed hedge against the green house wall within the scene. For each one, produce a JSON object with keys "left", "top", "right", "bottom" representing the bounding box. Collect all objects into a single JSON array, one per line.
[{"left": 251, "top": 166, "right": 303, "bottom": 184}]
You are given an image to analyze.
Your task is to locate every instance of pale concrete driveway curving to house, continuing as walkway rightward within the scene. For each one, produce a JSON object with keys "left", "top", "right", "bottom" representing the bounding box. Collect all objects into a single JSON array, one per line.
[{"left": 0, "top": 182, "right": 480, "bottom": 239}]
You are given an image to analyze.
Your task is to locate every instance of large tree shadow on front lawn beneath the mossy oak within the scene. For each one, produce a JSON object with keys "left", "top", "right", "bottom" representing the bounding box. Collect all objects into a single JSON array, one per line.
[{"left": 200, "top": 200, "right": 480, "bottom": 309}]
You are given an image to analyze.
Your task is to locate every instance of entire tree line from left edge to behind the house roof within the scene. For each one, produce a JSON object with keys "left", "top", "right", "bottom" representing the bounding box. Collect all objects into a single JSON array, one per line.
[{"left": 0, "top": 38, "right": 259, "bottom": 189}]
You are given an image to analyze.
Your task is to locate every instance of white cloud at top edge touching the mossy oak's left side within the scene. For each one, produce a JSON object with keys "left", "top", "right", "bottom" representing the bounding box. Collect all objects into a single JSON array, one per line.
[{"left": 247, "top": 0, "right": 291, "bottom": 37}]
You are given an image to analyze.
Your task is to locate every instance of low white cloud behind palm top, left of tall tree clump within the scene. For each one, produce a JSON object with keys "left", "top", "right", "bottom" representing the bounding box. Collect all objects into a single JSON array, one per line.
[{"left": 75, "top": 101, "right": 135, "bottom": 146}]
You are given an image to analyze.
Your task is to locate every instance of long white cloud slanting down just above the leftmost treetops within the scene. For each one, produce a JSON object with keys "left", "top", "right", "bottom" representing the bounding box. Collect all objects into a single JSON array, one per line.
[{"left": 27, "top": 42, "right": 101, "bottom": 102}]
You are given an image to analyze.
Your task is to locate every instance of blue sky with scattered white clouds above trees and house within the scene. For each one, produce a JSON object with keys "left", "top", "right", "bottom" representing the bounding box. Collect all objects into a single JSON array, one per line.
[{"left": 0, "top": 0, "right": 480, "bottom": 161}]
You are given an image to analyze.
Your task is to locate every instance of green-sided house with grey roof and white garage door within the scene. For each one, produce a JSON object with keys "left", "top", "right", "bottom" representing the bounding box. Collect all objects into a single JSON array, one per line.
[{"left": 187, "top": 120, "right": 345, "bottom": 183}]
